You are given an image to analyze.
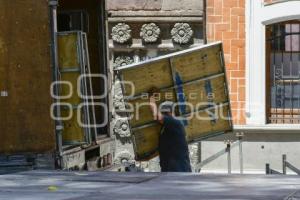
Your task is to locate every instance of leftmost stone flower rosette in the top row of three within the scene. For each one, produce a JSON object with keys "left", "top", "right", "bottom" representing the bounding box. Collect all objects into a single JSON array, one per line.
[{"left": 111, "top": 23, "right": 131, "bottom": 44}]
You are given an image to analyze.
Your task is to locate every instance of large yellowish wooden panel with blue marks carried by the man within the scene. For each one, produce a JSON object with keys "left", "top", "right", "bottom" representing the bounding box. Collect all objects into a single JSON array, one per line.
[{"left": 117, "top": 43, "right": 232, "bottom": 160}]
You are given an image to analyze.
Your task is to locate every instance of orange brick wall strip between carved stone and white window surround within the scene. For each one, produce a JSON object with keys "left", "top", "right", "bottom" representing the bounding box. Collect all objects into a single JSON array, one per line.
[{"left": 206, "top": 0, "right": 245, "bottom": 124}]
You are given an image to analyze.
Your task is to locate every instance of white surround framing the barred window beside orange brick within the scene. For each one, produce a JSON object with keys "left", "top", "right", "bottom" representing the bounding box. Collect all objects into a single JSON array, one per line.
[{"left": 245, "top": 0, "right": 300, "bottom": 127}]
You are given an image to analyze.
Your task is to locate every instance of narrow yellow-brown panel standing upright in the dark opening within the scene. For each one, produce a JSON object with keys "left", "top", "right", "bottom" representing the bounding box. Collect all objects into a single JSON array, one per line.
[{"left": 58, "top": 32, "right": 85, "bottom": 144}]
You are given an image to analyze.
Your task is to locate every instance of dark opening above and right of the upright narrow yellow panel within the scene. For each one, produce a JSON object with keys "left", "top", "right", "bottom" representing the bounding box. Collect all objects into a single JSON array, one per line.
[{"left": 57, "top": 0, "right": 109, "bottom": 141}]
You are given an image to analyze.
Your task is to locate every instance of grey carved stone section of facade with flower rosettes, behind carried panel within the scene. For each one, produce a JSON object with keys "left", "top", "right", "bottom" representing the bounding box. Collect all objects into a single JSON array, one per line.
[{"left": 107, "top": 0, "right": 204, "bottom": 171}]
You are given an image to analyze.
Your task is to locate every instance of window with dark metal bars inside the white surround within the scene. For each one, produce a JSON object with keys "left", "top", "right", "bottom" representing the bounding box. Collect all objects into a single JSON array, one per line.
[{"left": 266, "top": 20, "right": 300, "bottom": 124}]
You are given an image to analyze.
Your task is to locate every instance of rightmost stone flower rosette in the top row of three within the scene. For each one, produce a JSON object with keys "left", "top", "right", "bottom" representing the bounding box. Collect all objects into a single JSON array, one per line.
[{"left": 171, "top": 23, "right": 194, "bottom": 44}]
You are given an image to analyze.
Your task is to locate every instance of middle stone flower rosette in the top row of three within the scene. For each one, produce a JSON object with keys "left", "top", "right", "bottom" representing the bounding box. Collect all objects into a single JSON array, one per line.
[{"left": 140, "top": 23, "right": 160, "bottom": 43}]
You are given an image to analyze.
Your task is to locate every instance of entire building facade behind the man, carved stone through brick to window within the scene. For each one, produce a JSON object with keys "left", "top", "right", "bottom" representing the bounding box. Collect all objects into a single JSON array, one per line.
[{"left": 108, "top": 0, "right": 300, "bottom": 173}]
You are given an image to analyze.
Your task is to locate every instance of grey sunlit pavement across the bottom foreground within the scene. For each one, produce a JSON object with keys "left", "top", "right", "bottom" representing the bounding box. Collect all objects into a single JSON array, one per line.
[{"left": 0, "top": 171, "right": 300, "bottom": 200}]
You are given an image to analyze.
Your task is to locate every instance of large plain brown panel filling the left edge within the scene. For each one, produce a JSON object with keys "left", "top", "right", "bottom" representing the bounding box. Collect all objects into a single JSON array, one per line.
[{"left": 0, "top": 0, "right": 55, "bottom": 154}]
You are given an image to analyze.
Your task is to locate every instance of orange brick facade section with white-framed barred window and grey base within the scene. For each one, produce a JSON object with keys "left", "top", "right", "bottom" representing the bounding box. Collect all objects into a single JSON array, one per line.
[{"left": 202, "top": 0, "right": 300, "bottom": 173}]
